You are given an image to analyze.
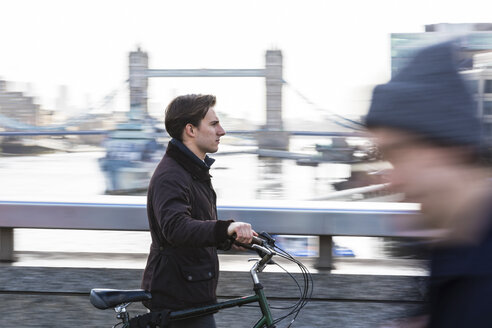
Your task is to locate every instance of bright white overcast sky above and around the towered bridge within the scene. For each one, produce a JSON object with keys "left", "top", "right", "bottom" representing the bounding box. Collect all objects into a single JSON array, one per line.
[{"left": 0, "top": 0, "right": 492, "bottom": 121}]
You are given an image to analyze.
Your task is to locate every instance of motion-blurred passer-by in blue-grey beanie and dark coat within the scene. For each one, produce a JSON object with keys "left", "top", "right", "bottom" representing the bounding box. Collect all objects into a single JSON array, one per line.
[{"left": 366, "top": 40, "right": 492, "bottom": 328}]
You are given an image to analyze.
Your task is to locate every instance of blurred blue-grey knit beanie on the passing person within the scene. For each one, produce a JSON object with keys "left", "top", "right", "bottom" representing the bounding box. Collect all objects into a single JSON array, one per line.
[{"left": 365, "top": 41, "right": 482, "bottom": 151}]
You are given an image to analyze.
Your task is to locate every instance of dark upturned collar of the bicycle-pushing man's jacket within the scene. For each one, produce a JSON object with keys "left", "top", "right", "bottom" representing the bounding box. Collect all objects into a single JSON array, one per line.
[{"left": 166, "top": 138, "right": 215, "bottom": 180}]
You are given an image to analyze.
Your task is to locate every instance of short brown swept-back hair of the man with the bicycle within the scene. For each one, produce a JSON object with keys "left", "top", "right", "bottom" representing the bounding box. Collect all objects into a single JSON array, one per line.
[{"left": 164, "top": 94, "right": 216, "bottom": 141}]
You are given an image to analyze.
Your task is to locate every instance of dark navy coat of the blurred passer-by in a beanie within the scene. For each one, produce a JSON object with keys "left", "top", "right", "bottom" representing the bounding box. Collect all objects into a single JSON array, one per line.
[{"left": 429, "top": 205, "right": 492, "bottom": 328}]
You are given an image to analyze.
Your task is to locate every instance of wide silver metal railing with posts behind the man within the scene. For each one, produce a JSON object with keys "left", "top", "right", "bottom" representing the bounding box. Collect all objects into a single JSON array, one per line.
[{"left": 0, "top": 196, "right": 426, "bottom": 268}]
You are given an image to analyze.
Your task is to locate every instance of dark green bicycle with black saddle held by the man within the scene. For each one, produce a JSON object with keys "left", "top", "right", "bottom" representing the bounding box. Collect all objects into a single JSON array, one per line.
[{"left": 90, "top": 232, "right": 313, "bottom": 328}]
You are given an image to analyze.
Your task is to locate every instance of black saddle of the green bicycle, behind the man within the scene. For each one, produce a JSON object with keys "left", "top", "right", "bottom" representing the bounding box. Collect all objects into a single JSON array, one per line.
[{"left": 90, "top": 289, "right": 152, "bottom": 310}]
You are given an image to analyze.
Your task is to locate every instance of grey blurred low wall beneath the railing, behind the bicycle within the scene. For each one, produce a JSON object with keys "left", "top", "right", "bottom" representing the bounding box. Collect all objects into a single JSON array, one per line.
[{"left": 0, "top": 265, "right": 426, "bottom": 328}]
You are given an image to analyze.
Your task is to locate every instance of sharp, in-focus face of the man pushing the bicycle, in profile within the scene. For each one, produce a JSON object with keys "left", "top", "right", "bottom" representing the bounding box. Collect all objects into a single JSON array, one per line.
[{"left": 195, "top": 107, "right": 225, "bottom": 156}]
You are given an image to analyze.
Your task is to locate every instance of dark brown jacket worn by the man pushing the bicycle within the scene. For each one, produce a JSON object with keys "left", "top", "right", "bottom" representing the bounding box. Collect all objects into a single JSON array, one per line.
[{"left": 142, "top": 139, "right": 230, "bottom": 310}]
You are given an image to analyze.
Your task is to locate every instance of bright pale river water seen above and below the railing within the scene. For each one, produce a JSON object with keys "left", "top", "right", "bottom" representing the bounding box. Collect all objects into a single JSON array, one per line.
[{"left": 0, "top": 140, "right": 390, "bottom": 258}]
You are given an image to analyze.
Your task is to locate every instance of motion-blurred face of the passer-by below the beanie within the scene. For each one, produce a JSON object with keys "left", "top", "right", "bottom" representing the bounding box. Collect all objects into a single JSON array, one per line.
[{"left": 371, "top": 128, "right": 463, "bottom": 208}]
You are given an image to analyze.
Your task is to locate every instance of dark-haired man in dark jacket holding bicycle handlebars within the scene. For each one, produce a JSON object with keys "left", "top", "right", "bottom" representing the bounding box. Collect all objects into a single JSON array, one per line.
[{"left": 142, "top": 95, "right": 256, "bottom": 328}]
